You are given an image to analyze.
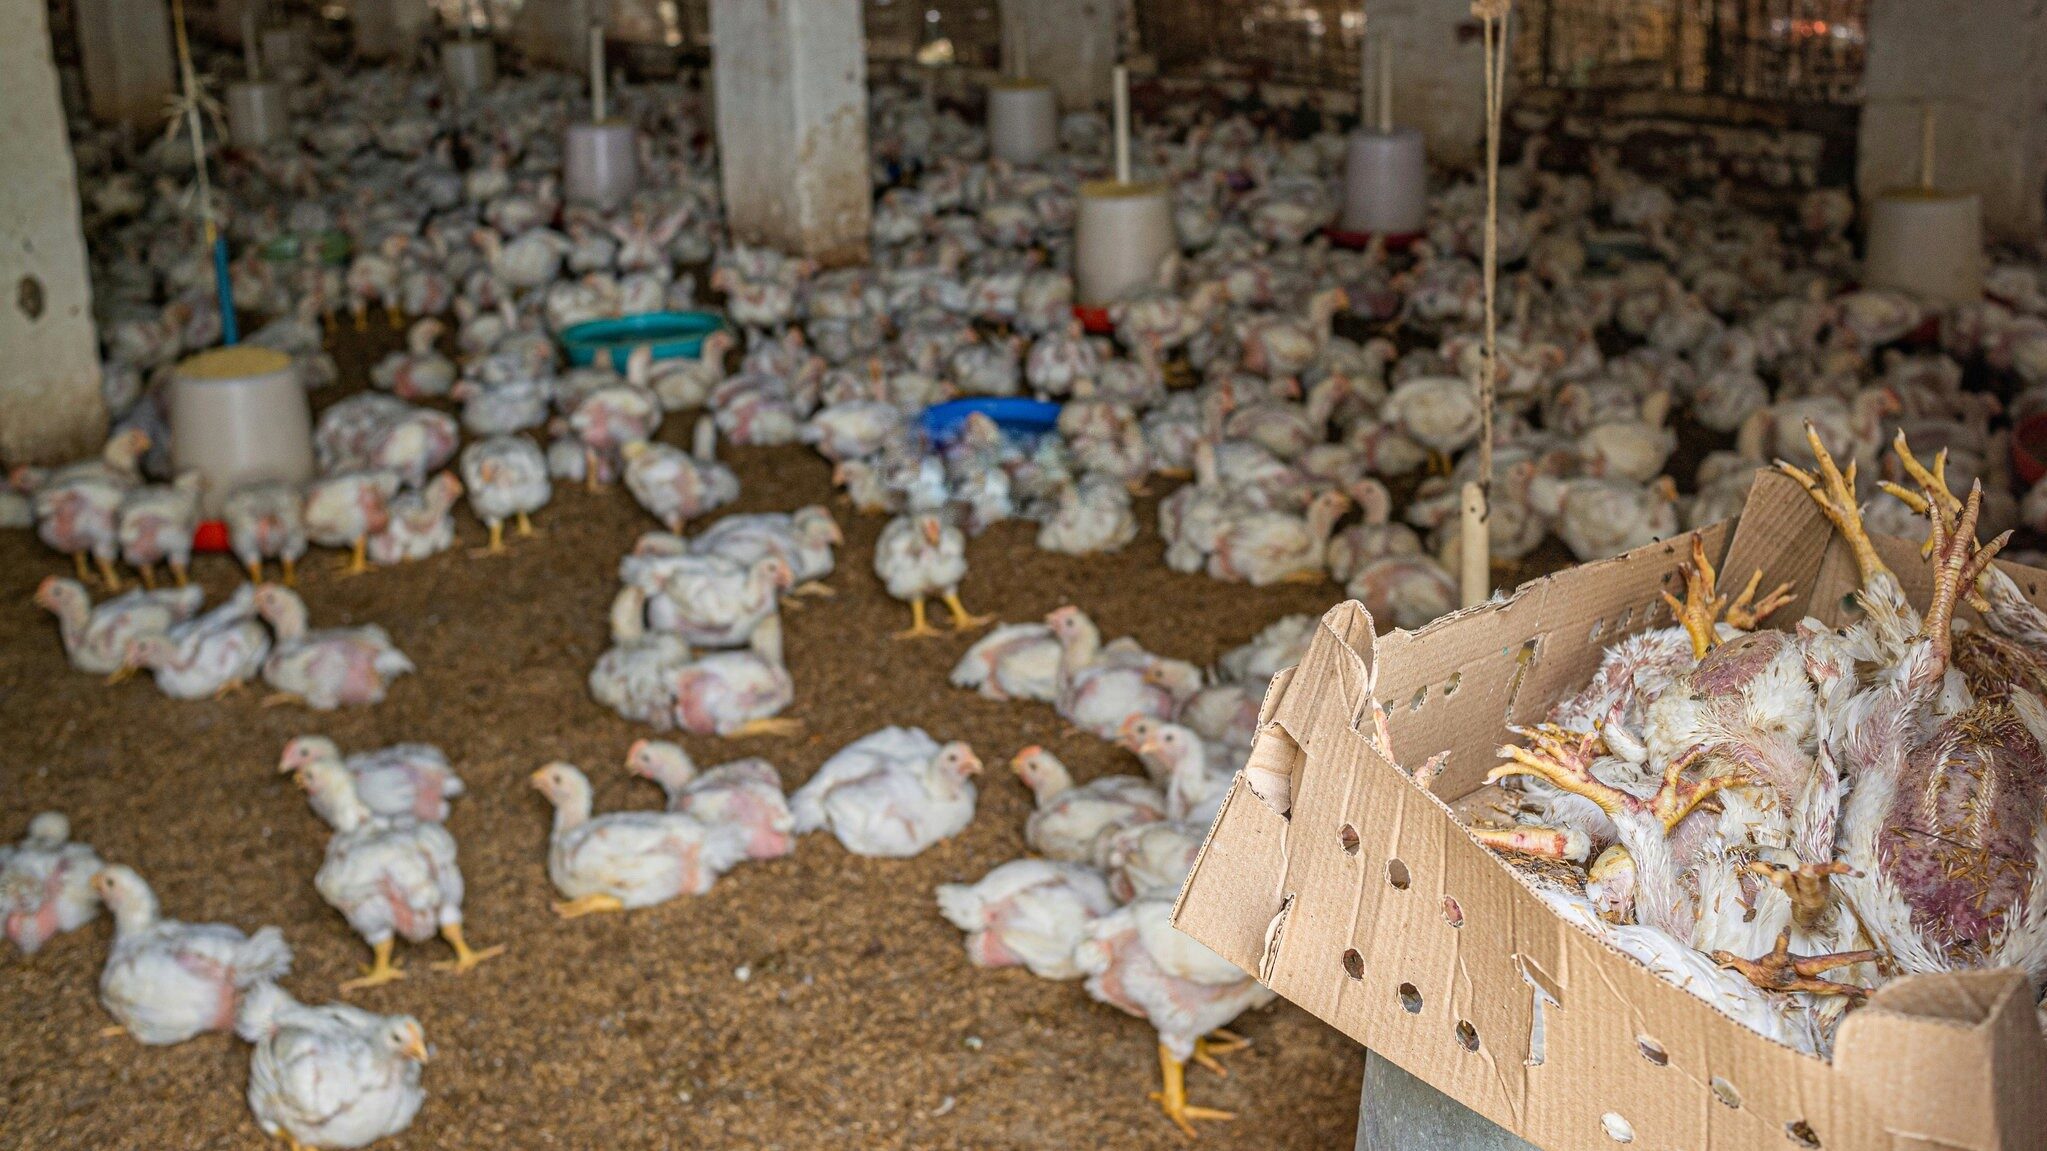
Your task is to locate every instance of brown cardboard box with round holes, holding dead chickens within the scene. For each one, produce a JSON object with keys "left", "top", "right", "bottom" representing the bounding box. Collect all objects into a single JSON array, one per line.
[{"left": 1175, "top": 473, "right": 2047, "bottom": 1151}]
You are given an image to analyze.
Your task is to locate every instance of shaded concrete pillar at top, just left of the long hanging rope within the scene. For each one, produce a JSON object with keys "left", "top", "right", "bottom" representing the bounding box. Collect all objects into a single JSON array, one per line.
[{"left": 1367, "top": 0, "right": 1490, "bottom": 164}]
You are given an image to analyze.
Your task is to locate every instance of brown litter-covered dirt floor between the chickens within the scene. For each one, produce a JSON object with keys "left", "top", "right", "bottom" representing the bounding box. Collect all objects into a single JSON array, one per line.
[{"left": 0, "top": 332, "right": 1361, "bottom": 1151}]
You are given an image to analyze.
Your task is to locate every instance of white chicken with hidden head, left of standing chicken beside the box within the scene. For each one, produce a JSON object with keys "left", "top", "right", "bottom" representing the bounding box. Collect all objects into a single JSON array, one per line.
[{"left": 938, "top": 860, "right": 1116, "bottom": 979}]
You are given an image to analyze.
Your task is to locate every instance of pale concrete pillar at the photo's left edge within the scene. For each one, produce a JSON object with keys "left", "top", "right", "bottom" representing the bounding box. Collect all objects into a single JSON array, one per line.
[{"left": 0, "top": 0, "right": 106, "bottom": 465}]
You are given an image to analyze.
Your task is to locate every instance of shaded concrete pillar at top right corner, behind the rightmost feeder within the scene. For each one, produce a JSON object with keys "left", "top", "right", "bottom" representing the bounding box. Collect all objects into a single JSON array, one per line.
[{"left": 1855, "top": 0, "right": 2047, "bottom": 242}]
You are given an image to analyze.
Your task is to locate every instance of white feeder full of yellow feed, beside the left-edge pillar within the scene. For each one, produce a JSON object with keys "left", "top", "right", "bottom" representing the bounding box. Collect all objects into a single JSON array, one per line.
[{"left": 170, "top": 344, "right": 313, "bottom": 516}]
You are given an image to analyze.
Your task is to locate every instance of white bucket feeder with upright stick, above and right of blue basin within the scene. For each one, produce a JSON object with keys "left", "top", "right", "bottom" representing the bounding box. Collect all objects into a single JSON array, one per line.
[{"left": 1073, "top": 66, "right": 1179, "bottom": 305}]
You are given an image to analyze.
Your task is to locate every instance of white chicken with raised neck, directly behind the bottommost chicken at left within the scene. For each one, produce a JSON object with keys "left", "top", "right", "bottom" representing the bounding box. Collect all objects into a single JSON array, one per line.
[{"left": 92, "top": 864, "right": 291, "bottom": 1047}]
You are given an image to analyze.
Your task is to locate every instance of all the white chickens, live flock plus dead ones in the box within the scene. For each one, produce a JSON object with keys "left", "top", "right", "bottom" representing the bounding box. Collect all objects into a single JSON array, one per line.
[{"left": 12, "top": 15, "right": 2047, "bottom": 1147}]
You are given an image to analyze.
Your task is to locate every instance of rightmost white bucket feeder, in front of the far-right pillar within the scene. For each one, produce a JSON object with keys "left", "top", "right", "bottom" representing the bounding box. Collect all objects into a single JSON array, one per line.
[{"left": 1863, "top": 106, "right": 1984, "bottom": 303}]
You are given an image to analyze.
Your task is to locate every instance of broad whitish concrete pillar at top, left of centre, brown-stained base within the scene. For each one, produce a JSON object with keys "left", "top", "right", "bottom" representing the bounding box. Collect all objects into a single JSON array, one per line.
[{"left": 710, "top": 0, "right": 872, "bottom": 264}]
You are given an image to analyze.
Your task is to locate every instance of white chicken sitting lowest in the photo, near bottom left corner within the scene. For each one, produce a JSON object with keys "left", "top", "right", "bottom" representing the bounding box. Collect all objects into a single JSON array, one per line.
[{"left": 235, "top": 983, "right": 426, "bottom": 1151}]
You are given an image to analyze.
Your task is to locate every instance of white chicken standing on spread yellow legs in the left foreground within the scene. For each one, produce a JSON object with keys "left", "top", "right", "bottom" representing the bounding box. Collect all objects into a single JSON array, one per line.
[{"left": 295, "top": 760, "right": 504, "bottom": 991}]
